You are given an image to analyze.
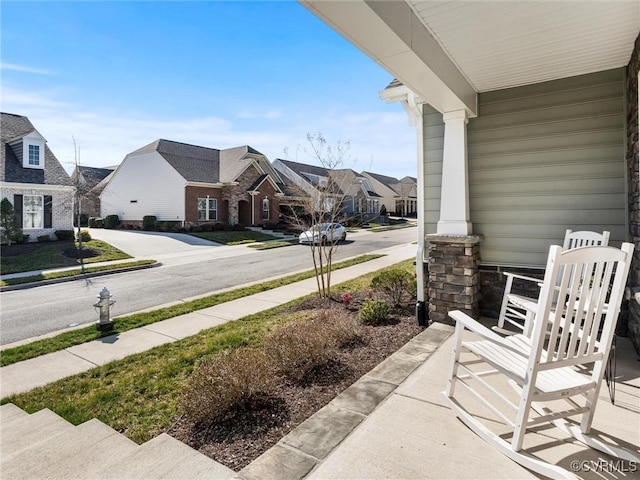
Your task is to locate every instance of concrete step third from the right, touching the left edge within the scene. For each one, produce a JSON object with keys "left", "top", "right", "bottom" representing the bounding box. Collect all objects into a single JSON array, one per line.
[{"left": 0, "top": 408, "right": 74, "bottom": 465}]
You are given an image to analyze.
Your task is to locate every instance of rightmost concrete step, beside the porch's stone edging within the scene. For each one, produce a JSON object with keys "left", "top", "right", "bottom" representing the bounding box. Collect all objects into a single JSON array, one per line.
[{"left": 92, "top": 433, "right": 235, "bottom": 480}]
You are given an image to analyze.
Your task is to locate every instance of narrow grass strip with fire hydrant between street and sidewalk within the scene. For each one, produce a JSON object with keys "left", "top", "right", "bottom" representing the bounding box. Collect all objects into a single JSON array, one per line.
[{"left": 0, "top": 255, "right": 382, "bottom": 367}]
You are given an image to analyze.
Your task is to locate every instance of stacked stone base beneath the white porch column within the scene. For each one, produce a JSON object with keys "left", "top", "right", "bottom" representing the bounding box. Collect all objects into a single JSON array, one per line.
[{"left": 425, "top": 235, "right": 482, "bottom": 325}]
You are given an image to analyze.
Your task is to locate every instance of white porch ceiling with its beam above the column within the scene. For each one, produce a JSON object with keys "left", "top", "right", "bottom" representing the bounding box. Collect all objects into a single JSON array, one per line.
[{"left": 301, "top": 0, "right": 640, "bottom": 116}]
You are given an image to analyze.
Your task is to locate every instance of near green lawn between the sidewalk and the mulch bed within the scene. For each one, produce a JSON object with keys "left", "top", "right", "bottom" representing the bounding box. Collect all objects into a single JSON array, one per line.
[{"left": 0, "top": 260, "right": 413, "bottom": 443}]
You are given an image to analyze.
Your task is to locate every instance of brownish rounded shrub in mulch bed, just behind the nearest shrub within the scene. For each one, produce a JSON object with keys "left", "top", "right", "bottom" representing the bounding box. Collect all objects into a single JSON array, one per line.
[{"left": 264, "top": 320, "right": 336, "bottom": 382}]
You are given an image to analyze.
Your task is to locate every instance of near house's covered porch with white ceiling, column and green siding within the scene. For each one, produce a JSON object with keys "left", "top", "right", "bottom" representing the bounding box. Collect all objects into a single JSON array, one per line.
[{"left": 301, "top": 0, "right": 640, "bottom": 351}]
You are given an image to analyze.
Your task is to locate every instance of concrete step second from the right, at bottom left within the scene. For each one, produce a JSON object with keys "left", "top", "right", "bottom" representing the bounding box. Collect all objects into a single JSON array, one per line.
[{"left": 2, "top": 419, "right": 138, "bottom": 480}]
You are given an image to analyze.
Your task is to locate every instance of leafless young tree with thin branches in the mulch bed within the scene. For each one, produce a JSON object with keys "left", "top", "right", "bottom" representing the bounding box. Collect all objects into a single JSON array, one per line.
[{"left": 284, "top": 134, "right": 351, "bottom": 297}]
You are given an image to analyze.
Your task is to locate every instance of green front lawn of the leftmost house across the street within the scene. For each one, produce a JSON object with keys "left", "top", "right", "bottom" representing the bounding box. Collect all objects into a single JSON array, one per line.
[{"left": 0, "top": 240, "right": 131, "bottom": 275}]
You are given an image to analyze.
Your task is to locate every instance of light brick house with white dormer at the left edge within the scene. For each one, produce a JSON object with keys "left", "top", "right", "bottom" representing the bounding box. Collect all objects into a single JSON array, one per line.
[{"left": 0, "top": 113, "right": 74, "bottom": 241}]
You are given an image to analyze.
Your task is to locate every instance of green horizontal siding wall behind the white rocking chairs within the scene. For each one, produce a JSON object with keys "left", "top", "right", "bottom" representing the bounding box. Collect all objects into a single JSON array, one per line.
[{"left": 470, "top": 69, "right": 626, "bottom": 266}]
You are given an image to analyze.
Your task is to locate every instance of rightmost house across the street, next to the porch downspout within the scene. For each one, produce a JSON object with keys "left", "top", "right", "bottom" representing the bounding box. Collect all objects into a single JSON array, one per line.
[{"left": 361, "top": 172, "right": 418, "bottom": 217}]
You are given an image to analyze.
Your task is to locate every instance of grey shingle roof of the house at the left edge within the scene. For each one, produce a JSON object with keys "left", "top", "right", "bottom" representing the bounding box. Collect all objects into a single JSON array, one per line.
[{"left": 0, "top": 112, "right": 73, "bottom": 186}]
